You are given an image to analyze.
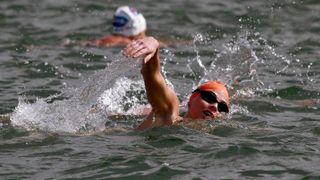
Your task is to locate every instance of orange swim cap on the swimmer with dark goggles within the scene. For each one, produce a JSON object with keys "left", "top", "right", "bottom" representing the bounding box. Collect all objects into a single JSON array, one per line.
[{"left": 189, "top": 80, "right": 230, "bottom": 105}]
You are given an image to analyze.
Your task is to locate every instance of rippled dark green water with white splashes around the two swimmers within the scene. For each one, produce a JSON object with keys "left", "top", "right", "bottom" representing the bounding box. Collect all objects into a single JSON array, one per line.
[{"left": 0, "top": 0, "right": 320, "bottom": 180}]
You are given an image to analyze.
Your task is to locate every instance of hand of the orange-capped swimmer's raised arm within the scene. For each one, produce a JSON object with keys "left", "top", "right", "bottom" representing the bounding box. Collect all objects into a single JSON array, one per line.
[{"left": 123, "top": 37, "right": 160, "bottom": 63}]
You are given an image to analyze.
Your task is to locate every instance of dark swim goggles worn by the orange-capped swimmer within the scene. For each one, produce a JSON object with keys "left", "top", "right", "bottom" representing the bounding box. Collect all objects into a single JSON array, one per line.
[{"left": 193, "top": 89, "right": 229, "bottom": 113}]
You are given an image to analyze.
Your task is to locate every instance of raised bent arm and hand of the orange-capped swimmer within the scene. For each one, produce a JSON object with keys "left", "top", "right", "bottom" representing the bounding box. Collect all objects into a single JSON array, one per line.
[{"left": 124, "top": 37, "right": 179, "bottom": 129}]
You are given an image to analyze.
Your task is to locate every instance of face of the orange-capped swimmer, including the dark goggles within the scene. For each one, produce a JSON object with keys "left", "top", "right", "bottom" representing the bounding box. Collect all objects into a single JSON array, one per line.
[{"left": 186, "top": 90, "right": 229, "bottom": 119}]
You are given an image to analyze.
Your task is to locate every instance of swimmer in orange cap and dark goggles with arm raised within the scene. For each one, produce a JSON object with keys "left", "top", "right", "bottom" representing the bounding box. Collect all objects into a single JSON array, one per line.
[{"left": 123, "top": 37, "right": 230, "bottom": 129}]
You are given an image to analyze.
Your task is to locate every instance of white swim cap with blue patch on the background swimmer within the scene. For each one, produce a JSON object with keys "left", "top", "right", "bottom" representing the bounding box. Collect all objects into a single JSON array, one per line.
[{"left": 112, "top": 6, "right": 147, "bottom": 36}]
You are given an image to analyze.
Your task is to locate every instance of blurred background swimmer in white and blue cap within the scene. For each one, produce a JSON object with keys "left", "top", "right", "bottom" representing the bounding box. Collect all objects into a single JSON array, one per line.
[{"left": 80, "top": 6, "right": 147, "bottom": 46}]
